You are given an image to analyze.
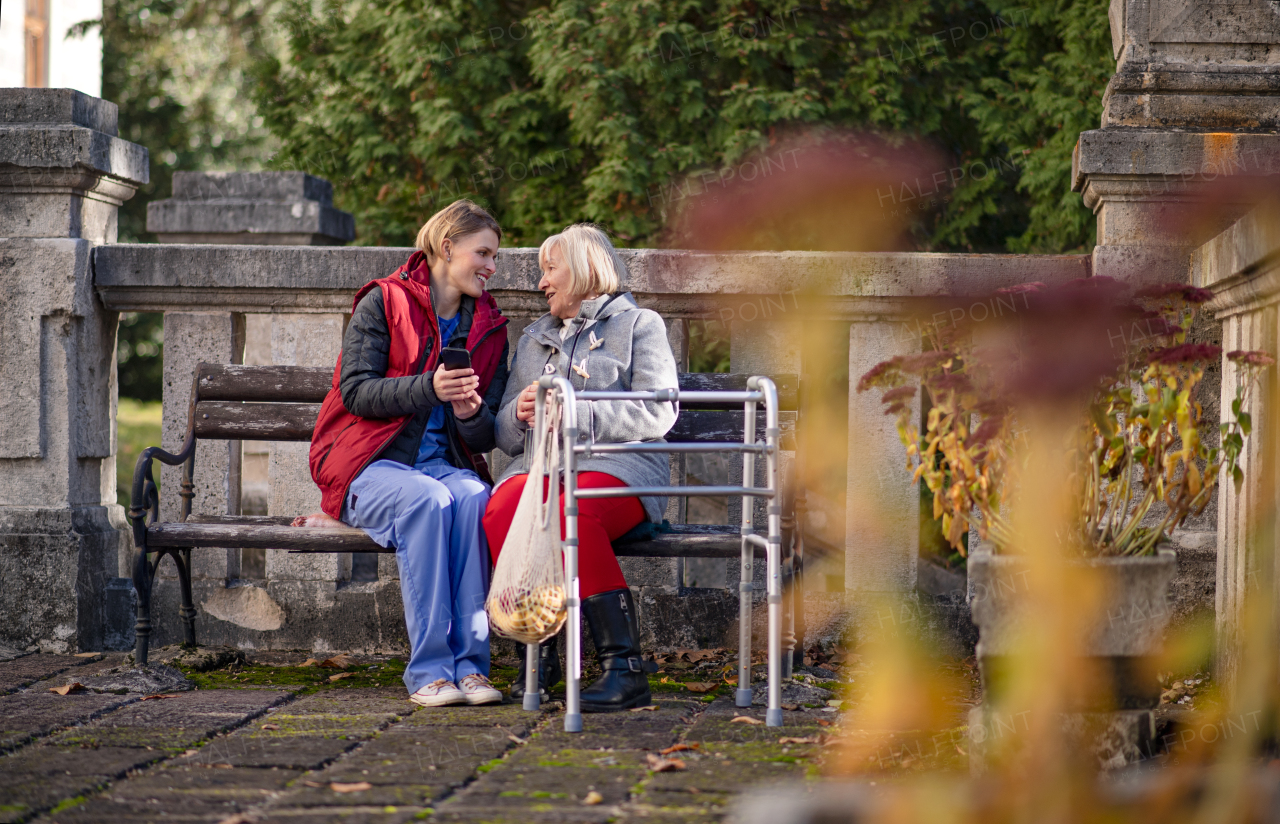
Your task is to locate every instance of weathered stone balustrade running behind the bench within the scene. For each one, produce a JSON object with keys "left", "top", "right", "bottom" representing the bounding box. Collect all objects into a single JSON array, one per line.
[{"left": 93, "top": 230, "right": 1089, "bottom": 649}]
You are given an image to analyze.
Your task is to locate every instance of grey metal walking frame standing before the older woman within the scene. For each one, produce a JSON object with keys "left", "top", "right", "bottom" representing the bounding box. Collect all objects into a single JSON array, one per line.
[{"left": 524, "top": 375, "right": 782, "bottom": 732}]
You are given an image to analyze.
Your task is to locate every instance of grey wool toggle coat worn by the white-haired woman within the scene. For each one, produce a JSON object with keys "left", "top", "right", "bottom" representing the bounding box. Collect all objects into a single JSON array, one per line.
[{"left": 495, "top": 292, "right": 680, "bottom": 522}]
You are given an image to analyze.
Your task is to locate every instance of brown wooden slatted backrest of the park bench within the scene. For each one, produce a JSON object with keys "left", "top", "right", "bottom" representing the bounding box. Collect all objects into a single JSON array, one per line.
[{"left": 191, "top": 363, "right": 799, "bottom": 448}]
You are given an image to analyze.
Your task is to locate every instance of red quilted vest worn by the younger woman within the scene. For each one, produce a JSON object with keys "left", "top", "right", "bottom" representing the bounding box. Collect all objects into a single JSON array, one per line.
[{"left": 310, "top": 252, "right": 507, "bottom": 518}]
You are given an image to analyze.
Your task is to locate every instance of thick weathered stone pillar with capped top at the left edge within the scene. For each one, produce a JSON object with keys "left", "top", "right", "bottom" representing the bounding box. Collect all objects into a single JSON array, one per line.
[{"left": 0, "top": 88, "right": 147, "bottom": 653}]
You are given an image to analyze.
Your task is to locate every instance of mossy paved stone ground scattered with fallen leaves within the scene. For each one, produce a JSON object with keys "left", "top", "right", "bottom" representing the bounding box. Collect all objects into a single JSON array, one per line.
[{"left": 0, "top": 654, "right": 836, "bottom": 824}]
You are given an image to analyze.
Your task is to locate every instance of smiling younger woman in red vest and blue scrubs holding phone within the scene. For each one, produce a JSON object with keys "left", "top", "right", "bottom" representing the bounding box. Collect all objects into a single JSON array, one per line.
[{"left": 311, "top": 200, "right": 507, "bottom": 706}]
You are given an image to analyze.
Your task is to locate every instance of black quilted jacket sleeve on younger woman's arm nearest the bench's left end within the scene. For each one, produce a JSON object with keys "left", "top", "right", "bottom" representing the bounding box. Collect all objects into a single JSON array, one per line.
[{"left": 338, "top": 289, "right": 440, "bottom": 418}]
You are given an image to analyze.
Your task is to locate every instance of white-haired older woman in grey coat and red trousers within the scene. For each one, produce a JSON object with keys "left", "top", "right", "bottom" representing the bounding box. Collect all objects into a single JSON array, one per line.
[{"left": 484, "top": 224, "right": 677, "bottom": 713}]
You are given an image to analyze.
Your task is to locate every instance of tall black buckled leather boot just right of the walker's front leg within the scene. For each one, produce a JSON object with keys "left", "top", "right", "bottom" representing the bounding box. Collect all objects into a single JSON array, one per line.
[{"left": 581, "top": 590, "right": 649, "bottom": 713}]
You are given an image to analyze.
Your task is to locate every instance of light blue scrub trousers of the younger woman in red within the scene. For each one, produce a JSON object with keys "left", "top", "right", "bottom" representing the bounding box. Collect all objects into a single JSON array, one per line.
[{"left": 343, "top": 459, "right": 489, "bottom": 693}]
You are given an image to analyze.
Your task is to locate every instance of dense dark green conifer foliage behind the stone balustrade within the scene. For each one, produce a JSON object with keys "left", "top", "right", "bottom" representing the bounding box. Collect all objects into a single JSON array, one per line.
[{"left": 256, "top": 0, "right": 1114, "bottom": 252}]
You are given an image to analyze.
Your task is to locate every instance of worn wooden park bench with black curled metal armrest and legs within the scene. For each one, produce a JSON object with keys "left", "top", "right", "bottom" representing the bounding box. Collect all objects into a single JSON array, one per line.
[{"left": 129, "top": 363, "right": 804, "bottom": 676}]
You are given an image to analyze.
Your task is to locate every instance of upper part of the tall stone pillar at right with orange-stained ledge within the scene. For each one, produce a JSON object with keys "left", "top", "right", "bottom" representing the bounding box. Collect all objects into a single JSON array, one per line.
[{"left": 1073, "top": 0, "right": 1280, "bottom": 281}]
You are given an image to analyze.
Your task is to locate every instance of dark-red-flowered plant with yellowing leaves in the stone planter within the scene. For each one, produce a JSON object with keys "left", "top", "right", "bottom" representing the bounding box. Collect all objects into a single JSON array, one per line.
[{"left": 858, "top": 278, "right": 1275, "bottom": 555}]
